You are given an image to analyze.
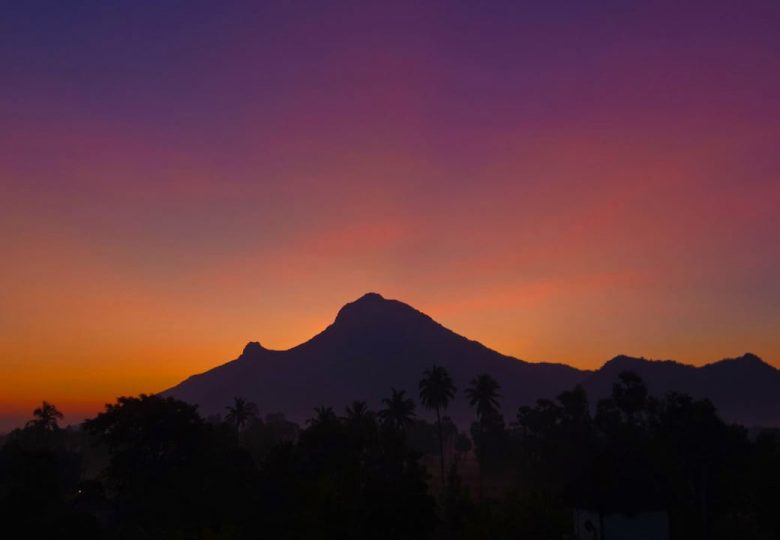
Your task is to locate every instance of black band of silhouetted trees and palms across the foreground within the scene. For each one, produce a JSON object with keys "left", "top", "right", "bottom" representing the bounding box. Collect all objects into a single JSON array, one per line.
[{"left": 0, "top": 367, "right": 780, "bottom": 540}]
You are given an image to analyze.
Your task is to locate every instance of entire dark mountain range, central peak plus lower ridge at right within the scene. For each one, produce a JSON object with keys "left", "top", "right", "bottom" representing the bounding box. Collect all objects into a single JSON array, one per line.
[{"left": 163, "top": 293, "right": 780, "bottom": 425}]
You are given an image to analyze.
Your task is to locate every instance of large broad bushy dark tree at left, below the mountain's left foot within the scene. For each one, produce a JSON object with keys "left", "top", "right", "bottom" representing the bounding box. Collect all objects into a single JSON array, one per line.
[{"left": 83, "top": 394, "right": 254, "bottom": 538}]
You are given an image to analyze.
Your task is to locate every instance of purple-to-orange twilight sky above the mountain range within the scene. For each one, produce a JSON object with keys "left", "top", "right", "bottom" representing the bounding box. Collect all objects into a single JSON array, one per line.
[{"left": 0, "top": 0, "right": 780, "bottom": 428}]
